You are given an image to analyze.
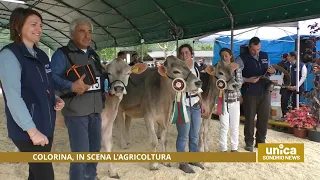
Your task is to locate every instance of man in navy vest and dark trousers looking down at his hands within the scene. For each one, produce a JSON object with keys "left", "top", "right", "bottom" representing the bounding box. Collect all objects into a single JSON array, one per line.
[{"left": 236, "top": 37, "right": 275, "bottom": 152}]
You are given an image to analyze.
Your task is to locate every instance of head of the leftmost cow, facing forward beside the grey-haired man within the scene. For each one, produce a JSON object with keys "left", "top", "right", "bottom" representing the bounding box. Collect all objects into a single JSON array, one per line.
[{"left": 104, "top": 59, "right": 148, "bottom": 96}]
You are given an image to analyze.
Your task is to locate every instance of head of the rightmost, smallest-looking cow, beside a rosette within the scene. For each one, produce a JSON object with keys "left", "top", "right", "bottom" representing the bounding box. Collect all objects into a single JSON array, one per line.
[{"left": 205, "top": 61, "right": 240, "bottom": 90}]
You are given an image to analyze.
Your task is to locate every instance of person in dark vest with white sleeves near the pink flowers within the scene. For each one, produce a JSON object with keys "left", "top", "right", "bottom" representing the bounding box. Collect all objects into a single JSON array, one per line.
[{"left": 281, "top": 51, "right": 307, "bottom": 119}]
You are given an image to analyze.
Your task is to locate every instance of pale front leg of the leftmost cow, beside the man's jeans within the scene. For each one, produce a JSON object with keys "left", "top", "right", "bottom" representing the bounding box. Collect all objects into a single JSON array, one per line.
[{"left": 101, "top": 113, "right": 122, "bottom": 179}]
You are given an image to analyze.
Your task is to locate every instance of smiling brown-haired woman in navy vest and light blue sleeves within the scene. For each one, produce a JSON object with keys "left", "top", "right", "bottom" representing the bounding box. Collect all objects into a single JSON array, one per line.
[{"left": 0, "top": 8, "right": 64, "bottom": 180}]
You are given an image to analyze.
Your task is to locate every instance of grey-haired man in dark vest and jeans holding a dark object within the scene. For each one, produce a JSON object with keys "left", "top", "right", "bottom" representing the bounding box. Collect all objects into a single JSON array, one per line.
[{"left": 51, "top": 17, "right": 104, "bottom": 180}]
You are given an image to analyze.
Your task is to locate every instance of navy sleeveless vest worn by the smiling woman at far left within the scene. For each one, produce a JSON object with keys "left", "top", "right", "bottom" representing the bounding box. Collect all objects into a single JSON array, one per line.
[{"left": 3, "top": 43, "right": 56, "bottom": 140}]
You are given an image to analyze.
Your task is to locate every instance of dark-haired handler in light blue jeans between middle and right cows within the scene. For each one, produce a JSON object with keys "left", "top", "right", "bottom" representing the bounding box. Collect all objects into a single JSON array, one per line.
[{"left": 176, "top": 44, "right": 204, "bottom": 173}]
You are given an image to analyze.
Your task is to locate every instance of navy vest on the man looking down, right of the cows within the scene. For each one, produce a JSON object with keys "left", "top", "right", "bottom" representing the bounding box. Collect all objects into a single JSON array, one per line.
[{"left": 240, "top": 51, "right": 269, "bottom": 96}]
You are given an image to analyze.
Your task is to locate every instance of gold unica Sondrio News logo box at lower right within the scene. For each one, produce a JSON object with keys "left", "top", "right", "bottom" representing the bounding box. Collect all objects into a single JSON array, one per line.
[{"left": 258, "top": 143, "right": 304, "bottom": 162}]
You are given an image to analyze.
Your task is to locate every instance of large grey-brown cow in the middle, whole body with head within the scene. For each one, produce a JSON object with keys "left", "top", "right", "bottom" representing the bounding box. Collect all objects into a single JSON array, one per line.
[{"left": 109, "top": 56, "right": 202, "bottom": 174}]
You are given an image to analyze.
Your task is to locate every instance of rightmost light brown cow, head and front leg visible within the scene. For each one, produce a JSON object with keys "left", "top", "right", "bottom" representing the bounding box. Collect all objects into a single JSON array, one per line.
[{"left": 199, "top": 61, "right": 239, "bottom": 152}]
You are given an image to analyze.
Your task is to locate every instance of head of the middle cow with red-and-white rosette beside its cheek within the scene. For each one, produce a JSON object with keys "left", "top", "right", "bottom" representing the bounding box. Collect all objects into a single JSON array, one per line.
[{"left": 158, "top": 56, "right": 202, "bottom": 92}]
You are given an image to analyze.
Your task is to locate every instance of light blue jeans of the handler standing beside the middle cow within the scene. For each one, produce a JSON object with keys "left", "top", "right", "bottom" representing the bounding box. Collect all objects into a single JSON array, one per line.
[{"left": 176, "top": 106, "right": 202, "bottom": 152}]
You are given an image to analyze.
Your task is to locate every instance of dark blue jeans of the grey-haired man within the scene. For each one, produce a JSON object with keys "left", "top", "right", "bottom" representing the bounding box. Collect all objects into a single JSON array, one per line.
[{"left": 65, "top": 113, "right": 101, "bottom": 180}]
